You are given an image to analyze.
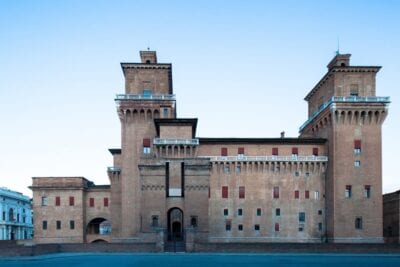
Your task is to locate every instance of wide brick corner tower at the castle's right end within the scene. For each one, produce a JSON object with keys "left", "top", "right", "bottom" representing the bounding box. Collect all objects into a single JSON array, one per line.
[{"left": 300, "top": 54, "right": 390, "bottom": 242}]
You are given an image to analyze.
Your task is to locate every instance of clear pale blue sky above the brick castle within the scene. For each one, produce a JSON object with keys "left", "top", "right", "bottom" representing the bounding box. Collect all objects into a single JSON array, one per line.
[{"left": 0, "top": 0, "right": 400, "bottom": 196}]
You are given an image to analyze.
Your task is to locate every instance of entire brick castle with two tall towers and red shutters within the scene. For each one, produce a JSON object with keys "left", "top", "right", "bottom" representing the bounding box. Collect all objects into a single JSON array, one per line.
[{"left": 30, "top": 51, "right": 390, "bottom": 248}]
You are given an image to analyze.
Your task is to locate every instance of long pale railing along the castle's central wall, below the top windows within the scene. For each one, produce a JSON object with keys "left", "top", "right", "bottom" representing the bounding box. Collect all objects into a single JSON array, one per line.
[{"left": 201, "top": 156, "right": 328, "bottom": 162}]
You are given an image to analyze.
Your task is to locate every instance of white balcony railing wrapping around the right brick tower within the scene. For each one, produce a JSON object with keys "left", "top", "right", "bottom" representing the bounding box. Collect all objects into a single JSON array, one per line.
[{"left": 300, "top": 96, "right": 390, "bottom": 132}]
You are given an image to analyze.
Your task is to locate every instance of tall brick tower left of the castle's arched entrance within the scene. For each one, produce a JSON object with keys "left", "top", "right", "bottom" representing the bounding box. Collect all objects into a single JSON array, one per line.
[{"left": 108, "top": 51, "right": 176, "bottom": 240}]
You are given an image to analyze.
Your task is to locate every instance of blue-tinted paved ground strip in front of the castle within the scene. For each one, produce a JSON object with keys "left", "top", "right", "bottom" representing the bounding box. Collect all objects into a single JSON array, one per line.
[{"left": 0, "top": 253, "right": 400, "bottom": 267}]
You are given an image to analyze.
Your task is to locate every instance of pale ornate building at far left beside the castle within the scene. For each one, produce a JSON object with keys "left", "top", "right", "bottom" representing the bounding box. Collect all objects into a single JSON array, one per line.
[{"left": 0, "top": 187, "right": 33, "bottom": 240}]
